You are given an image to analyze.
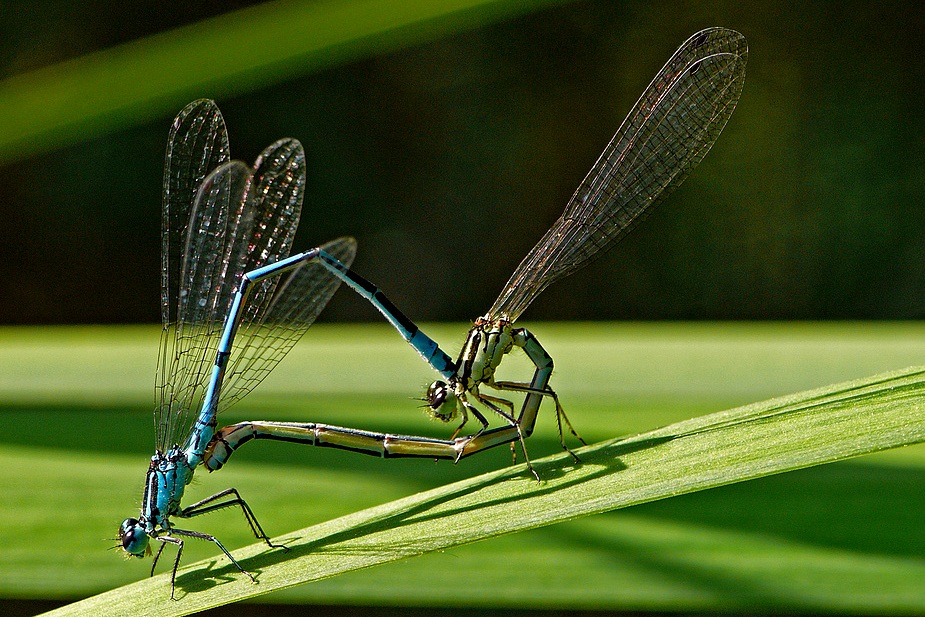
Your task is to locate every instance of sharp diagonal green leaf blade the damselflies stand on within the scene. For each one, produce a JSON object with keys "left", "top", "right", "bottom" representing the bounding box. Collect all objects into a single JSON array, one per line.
[{"left": 43, "top": 368, "right": 925, "bottom": 617}]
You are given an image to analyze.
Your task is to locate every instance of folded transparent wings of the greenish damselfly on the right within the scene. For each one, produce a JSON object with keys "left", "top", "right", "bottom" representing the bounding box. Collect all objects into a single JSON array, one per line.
[{"left": 488, "top": 28, "right": 748, "bottom": 321}]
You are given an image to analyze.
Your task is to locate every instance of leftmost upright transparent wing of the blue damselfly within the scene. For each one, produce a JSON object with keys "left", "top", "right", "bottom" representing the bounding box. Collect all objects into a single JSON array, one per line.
[{"left": 155, "top": 100, "right": 231, "bottom": 447}]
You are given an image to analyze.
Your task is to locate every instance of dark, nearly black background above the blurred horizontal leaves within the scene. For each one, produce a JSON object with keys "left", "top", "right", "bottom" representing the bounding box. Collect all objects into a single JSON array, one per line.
[{"left": 0, "top": 0, "right": 925, "bottom": 324}]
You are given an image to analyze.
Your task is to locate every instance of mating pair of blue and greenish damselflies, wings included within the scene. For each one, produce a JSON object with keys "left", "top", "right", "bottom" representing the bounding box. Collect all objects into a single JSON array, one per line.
[{"left": 119, "top": 28, "right": 747, "bottom": 597}]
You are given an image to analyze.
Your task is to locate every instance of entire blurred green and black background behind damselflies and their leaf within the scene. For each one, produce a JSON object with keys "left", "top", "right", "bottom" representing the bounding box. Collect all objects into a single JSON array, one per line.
[{"left": 0, "top": 0, "right": 925, "bottom": 614}]
